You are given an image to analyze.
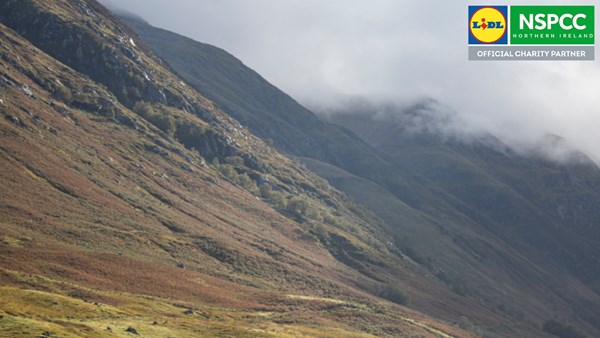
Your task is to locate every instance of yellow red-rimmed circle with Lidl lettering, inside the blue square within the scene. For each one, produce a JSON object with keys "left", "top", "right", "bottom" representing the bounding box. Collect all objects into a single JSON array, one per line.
[{"left": 469, "top": 7, "right": 506, "bottom": 43}]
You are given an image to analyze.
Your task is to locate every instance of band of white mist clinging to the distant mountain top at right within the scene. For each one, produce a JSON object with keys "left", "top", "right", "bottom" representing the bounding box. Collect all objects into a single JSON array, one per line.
[{"left": 316, "top": 97, "right": 593, "bottom": 163}]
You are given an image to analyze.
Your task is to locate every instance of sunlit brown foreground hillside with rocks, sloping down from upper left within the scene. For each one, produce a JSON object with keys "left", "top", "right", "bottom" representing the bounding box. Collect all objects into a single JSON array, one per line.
[{"left": 0, "top": 0, "right": 482, "bottom": 337}]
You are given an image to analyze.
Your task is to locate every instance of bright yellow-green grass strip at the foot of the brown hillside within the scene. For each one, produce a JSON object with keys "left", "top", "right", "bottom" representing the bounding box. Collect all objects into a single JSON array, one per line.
[{"left": 0, "top": 278, "right": 374, "bottom": 338}]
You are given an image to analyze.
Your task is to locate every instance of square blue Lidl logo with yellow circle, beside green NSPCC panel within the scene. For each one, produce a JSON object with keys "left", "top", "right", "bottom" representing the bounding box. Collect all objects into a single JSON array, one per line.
[{"left": 469, "top": 6, "right": 508, "bottom": 45}]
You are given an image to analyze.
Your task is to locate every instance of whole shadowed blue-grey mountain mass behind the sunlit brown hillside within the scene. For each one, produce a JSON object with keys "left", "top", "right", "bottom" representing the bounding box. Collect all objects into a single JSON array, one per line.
[{"left": 119, "top": 12, "right": 600, "bottom": 336}]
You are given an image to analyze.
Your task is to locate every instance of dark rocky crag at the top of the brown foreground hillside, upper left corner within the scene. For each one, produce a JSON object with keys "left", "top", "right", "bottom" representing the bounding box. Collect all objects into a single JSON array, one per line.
[{"left": 0, "top": 0, "right": 184, "bottom": 110}]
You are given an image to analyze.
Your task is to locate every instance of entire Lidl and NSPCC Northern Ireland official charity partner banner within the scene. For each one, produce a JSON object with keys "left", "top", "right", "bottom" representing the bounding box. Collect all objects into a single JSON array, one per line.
[{"left": 468, "top": 6, "right": 595, "bottom": 61}]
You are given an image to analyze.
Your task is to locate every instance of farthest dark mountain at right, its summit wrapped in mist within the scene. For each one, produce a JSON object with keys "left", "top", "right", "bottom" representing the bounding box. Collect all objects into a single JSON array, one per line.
[{"left": 330, "top": 99, "right": 600, "bottom": 282}]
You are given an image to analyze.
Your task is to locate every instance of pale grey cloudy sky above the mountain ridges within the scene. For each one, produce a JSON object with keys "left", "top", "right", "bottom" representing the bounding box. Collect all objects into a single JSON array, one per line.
[{"left": 100, "top": 0, "right": 600, "bottom": 162}]
